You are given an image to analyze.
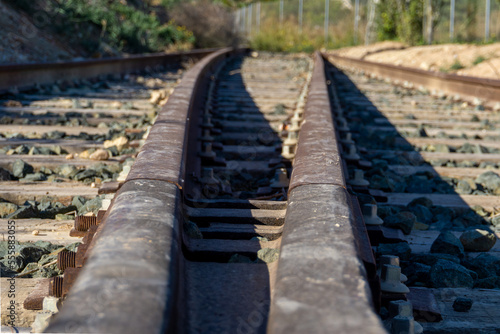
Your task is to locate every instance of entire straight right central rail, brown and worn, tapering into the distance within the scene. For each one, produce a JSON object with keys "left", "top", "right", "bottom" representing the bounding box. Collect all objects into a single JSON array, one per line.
[{"left": 268, "top": 53, "right": 386, "bottom": 334}]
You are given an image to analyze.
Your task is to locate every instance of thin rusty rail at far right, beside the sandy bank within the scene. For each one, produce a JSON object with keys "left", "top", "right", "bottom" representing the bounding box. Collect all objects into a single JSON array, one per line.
[{"left": 324, "top": 53, "right": 500, "bottom": 102}]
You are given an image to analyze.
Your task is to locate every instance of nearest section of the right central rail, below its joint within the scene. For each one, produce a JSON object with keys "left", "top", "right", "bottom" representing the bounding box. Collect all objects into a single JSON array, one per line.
[{"left": 268, "top": 184, "right": 385, "bottom": 333}]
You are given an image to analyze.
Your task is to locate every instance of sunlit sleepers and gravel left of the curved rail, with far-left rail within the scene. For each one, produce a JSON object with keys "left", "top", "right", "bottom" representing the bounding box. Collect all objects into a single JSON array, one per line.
[{"left": 0, "top": 50, "right": 211, "bottom": 330}]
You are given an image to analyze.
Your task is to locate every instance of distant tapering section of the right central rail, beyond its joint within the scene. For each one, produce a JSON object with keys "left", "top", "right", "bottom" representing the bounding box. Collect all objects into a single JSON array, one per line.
[{"left": 289, "top": 53, "right": 345, "bottom": 192}]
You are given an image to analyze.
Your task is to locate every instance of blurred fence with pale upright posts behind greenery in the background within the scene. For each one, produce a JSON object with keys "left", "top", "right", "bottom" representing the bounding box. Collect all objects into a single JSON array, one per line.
[{"left": 235, "top": 0, "right": 500, "bottom": 51}]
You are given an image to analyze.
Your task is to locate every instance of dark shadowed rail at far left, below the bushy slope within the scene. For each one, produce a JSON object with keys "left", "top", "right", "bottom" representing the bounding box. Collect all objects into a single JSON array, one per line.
[{"left": 0, "top": 49, "right": 217, "bottom": 93}]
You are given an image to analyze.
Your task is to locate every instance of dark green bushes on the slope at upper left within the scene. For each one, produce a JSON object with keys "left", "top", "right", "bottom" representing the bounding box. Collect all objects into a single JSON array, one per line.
[{"left": 7, "top": 0, "right": 195, "bottom": 55}]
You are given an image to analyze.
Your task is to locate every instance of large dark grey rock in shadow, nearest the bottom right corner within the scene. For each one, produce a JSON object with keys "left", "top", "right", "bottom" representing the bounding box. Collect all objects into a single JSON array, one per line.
[{"left": 429, "top": 260, "right": 474, "bottom": 288}]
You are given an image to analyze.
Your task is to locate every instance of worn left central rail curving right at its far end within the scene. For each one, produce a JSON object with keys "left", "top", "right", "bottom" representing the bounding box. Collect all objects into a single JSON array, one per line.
[{"left": 46, "top": 49, "right": 234, "bottom": 333}]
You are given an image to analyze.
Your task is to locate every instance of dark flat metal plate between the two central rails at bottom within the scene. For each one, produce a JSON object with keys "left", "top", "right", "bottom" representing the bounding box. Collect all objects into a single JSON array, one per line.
[{"left": 181, "top": 262, "right": 271, "bottom": 334}]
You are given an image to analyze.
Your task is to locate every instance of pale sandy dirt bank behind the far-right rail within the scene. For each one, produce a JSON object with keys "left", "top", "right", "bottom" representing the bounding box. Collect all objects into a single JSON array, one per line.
[{"left": 331, "top": 42, "right": 500, "bottom": 80}]
